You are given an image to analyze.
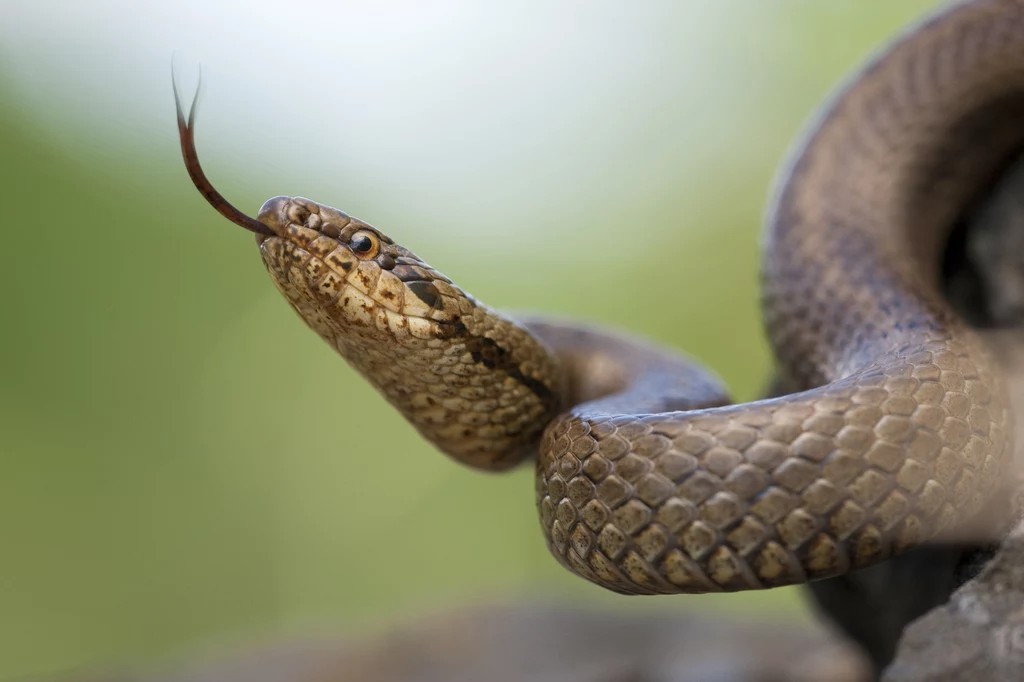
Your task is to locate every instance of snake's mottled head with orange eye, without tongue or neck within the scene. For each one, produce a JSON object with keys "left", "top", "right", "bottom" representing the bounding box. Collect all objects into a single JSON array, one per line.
[{"left": 256, "top": 197, "right": 473, "bottom": 343}]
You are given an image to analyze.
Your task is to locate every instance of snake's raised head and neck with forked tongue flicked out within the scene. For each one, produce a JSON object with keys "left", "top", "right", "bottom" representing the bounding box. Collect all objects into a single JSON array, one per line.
[{"left": 172, "top": 76, "right": 562, "bottom": 470}]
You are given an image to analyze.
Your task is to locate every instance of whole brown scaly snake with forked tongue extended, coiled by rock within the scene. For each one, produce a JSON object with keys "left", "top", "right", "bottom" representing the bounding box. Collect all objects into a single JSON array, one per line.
[{"left": 172, "top": 0, "right": 1024, "bottom": 594}]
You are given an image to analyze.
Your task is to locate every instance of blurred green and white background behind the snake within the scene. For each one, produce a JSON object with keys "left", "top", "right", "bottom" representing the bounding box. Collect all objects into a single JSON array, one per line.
[{"left": 0, "top": 0, "right": 933, "bottom": 677}]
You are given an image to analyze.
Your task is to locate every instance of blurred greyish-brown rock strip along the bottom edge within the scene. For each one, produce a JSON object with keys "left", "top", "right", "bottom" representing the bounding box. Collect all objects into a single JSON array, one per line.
[{"left": 44, "top": 604, "right": 871, "bottom": 682}]
